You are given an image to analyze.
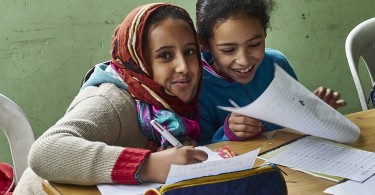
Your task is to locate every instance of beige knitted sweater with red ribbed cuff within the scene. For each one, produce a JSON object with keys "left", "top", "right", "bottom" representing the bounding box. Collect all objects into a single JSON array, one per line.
[{"left": 15, "top": 83, "right": 150, "bottom": 194}]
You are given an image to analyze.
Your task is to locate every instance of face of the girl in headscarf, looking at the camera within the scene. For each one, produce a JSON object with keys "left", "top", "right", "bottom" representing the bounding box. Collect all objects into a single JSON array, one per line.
[{"left": 144, "top": 18, "right": 200, "bottom": 103}]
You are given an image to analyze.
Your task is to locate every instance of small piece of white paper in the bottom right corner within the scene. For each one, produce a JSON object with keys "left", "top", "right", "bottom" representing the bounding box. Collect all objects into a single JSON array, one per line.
[{"left": 324, "top": 176, "right": 375, "bottom": 195}]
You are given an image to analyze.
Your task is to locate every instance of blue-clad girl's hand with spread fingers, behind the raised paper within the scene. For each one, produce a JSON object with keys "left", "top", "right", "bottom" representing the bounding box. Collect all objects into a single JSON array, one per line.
[{"left": 314, "top": 87, "right": 346, "bottom": 109}]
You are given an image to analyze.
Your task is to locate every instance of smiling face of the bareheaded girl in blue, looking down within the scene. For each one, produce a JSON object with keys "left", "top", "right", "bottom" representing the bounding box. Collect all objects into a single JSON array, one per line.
[{"left": 208, "top": 15, "right": 267, "bottom": 84}]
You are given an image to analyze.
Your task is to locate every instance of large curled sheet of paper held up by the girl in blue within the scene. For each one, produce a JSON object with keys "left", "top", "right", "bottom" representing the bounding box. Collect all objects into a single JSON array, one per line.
[{"left": 219, "top": 65, "right": 360, "bottom": 143}]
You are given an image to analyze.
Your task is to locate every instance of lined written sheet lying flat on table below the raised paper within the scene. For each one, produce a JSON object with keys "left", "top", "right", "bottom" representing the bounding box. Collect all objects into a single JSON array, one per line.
[{"left": 267, "top": 136, "right": 375, "bottom": 182}]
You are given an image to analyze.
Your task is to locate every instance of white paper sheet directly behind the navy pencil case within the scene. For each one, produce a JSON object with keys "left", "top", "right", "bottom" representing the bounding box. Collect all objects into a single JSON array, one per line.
[{"left": 166, "top": 148, "right": 260, "bottom": 184}]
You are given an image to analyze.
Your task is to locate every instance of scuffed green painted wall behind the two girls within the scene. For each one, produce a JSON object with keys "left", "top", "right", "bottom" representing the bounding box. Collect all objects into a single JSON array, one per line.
[{"left": 0, "top": 0, "right": 375, "bottom": 165}]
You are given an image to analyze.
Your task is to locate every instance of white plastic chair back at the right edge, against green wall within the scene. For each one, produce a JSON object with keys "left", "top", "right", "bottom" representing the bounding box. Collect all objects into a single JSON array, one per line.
[{"left": 345, "top": 18, "right": 375, "bottom": 110}]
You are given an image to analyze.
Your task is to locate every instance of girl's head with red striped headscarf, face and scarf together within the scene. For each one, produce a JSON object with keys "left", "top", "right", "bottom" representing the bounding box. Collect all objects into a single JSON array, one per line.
[{"left": 111, "top": 2, "right": 202, "bottom": 148}]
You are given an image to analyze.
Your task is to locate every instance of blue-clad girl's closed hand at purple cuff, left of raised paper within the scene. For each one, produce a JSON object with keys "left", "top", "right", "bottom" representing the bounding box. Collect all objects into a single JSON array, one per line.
[{"left": 228, "top": 112, "right": 262, "bottom": 139}]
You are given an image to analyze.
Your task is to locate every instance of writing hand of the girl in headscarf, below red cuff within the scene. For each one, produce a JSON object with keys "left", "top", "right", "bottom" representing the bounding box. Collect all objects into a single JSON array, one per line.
[{"left": 139, "top": 146, "right": 208, "bottom": 183}]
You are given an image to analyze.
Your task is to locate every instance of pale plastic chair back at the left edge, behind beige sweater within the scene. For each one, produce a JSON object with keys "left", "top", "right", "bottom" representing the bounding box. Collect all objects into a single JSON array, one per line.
[{"left": 0, "top": 94, "right": 35, "bottom": 183}]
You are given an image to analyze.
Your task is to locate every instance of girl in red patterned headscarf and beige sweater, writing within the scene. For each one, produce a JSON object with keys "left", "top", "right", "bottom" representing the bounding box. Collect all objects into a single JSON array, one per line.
[{"left": 15, "top": 3, "right": 207, "bottom": 194}]
